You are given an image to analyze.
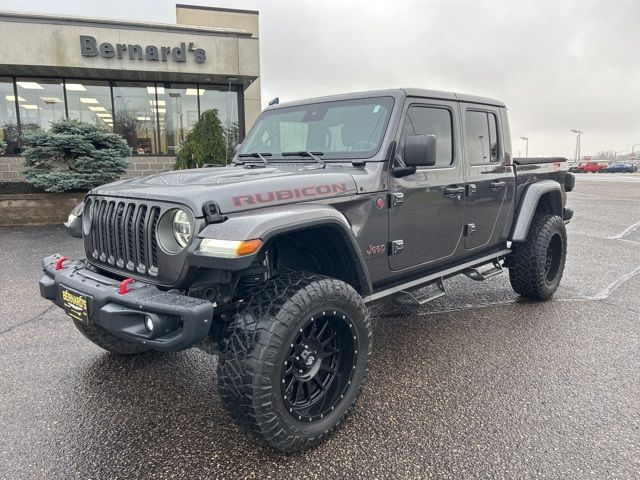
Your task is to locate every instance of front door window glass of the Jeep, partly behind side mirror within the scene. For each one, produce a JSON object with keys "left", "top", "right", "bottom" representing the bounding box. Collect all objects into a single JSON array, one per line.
[{"left": 400, "top": 106, "right": 453, "bottom": 167}]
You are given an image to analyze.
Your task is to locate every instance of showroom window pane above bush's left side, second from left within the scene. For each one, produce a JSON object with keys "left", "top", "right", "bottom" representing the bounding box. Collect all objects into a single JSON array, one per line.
[{"left": 16, "top": 78, "right": 66, "bottom": 133}]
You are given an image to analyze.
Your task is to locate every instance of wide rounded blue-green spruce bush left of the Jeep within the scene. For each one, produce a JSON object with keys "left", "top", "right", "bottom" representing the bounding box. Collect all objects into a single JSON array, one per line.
[{"left": 23, "top": 119, "right": 131, "bottom": 192}]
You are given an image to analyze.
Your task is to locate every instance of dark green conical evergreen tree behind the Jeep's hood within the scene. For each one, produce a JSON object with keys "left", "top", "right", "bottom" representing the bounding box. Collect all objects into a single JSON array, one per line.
[{"left": 175, "top": 108, "right": 228, "bottom": 169}]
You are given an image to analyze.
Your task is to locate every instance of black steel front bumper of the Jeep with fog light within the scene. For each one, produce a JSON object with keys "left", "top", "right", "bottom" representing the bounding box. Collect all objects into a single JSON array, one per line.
[{"left": 40, "top": 255, "right": 214, "bottom": 352}]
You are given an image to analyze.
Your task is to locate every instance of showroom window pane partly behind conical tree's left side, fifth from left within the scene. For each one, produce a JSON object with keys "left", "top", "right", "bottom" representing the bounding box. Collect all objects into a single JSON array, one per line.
[{"left": 157, "top": 83, "right": 198, "bottom": 155}]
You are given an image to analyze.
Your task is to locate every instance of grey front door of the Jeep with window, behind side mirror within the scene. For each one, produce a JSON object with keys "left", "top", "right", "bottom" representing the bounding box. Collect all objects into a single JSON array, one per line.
[{"left": 389, "top": 98, "right": 465, "bottom": 271}]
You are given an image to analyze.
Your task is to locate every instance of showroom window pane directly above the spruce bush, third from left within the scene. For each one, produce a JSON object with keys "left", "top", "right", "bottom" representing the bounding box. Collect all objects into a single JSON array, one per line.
[{"left": 65, "top": 80, "right": 113, "bottom": 130}]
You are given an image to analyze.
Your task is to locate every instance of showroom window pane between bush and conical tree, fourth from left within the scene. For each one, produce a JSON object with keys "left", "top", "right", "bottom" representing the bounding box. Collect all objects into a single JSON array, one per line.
[{"left": 113, "top": 82, "right": 159, "bottom": 155}]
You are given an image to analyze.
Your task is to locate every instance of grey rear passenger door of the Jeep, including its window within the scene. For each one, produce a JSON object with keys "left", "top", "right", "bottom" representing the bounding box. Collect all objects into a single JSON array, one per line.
[{"left": 460, "top": 103, "right": 510, "bottom": 250}]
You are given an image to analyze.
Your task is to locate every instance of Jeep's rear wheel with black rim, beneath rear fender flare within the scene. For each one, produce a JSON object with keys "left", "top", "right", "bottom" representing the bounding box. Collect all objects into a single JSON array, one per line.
[{"left": 508, "top": 214, "right": 567, "bottom": 300}]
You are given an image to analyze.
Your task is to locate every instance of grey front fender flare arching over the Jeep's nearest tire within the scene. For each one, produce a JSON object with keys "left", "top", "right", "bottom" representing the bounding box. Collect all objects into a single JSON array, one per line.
[{"left": 189, "top": 203, "right": 373, "bottom": 296}]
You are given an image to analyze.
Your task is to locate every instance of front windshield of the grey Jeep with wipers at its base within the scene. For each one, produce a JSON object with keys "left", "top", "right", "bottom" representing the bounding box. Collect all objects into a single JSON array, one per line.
[{"left": 238, "top": 97, "right": 393, "bottom": 160}]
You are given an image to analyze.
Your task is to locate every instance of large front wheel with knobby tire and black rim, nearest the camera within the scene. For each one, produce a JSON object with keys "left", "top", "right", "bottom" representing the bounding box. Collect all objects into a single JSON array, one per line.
[{"left": 218, "top": 272, "right": 371, "bottom": 452}]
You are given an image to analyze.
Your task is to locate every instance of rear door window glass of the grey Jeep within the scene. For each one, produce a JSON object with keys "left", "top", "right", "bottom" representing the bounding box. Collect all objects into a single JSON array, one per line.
[{"left": 465, "top": 110, "right": 500, "bottom": 165}]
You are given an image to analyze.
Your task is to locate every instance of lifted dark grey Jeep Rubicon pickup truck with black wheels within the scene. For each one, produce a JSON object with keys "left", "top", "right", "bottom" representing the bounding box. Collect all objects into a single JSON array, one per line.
[{"left": 40, "top": 89, "right": 574, "bottom": 452}]
